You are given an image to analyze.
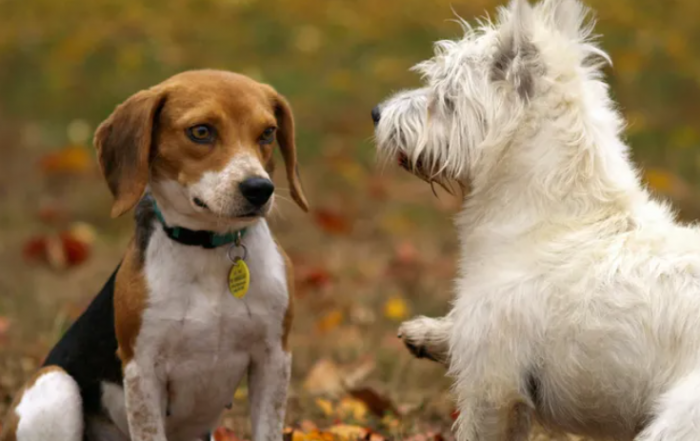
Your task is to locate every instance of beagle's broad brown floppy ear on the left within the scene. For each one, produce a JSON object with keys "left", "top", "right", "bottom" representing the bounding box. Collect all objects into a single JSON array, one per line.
[{"left": 93, "top": 89, "right": 165, "bottom": 217}]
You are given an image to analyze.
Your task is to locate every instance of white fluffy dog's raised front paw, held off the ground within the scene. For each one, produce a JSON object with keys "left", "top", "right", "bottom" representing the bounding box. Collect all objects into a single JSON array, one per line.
[{"left": 399, "top": 316, "right": 452, "bottom": 365}]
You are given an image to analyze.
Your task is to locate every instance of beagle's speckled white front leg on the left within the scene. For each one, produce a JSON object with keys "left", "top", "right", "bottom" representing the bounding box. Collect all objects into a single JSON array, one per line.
[{"left": 124, "top": 360, "right": 167, "bottom": 441}]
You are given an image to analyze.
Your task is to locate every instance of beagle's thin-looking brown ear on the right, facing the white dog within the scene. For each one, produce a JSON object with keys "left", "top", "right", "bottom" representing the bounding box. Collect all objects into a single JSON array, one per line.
[{"left": 275, "top": 94, "right": 309, "bottom": 211}]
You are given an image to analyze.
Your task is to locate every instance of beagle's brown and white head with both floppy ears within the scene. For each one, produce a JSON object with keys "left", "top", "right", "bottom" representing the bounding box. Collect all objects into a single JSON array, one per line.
[{"left": 94, "top": 70, "right": 308, "bottom": 229}]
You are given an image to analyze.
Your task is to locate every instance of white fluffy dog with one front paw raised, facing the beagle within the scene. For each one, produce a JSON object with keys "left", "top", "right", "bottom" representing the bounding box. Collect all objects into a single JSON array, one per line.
[{"left": 372, "top": 0, "right": 700, "bottom": 441}]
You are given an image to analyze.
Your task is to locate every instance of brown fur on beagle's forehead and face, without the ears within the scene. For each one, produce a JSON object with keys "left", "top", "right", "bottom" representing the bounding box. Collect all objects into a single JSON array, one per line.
[{"left": 152, "top": 71, "right": 277, "bottom": 185}]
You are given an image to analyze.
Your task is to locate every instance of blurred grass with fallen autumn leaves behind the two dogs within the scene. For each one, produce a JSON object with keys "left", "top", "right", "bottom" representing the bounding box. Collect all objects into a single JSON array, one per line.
[{"left": 0, "top": 0, "right": 700, "bottom": 437}]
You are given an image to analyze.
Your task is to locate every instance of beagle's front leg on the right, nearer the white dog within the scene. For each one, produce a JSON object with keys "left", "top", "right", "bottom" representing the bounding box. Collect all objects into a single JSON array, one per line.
[{"left": 249, "top": 345, "right": 292, "bottom": 441}]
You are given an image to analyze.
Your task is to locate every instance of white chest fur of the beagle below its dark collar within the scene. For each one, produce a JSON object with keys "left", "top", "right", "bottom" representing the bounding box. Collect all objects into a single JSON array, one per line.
[{"left": 101, "top": 221, "right": 289, "bottom": 440}]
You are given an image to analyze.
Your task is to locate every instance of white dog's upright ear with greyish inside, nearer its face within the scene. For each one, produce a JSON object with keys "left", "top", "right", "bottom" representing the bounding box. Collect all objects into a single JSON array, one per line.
[{"left": 492, "top": 0, "right": 540, "bottom": 100}]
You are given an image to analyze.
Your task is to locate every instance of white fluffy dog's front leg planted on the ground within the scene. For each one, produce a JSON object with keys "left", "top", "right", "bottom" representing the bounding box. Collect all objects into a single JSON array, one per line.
[{"left": 449, "top": 293, "right": 542, "bottom": 441}]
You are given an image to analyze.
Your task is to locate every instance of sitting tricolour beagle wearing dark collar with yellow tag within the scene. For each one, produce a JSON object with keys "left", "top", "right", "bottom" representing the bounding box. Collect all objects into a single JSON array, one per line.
[{"left": 0, "top": 70, "right": 308, "bottom": 441}]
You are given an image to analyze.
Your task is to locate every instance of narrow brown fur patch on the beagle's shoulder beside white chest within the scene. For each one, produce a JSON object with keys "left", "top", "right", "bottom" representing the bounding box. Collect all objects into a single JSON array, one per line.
[{"left": 114, "top": 241, "right": 147, "bottom": 366}]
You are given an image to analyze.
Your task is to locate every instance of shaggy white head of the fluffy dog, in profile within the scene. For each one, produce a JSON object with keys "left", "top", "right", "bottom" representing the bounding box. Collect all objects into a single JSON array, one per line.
[{"left": 372, "top": 0, "right": 607, "bottom": 192}]
